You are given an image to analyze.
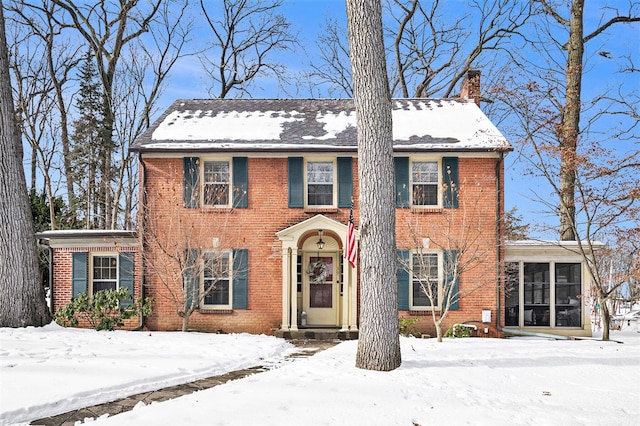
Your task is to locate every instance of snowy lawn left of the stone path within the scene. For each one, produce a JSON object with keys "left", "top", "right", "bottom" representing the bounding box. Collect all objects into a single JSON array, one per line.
[{"left": 0, "top": 323, "right": 295, "bottom": 425}]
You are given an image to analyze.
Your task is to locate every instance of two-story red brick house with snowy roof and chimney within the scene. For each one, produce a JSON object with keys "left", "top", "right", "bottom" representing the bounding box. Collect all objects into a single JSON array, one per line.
[{"left": 41, "top": 74, "right": 588, "bottom": 338}]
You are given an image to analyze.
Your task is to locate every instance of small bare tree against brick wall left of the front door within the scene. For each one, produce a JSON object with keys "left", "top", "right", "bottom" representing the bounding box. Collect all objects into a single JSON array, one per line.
[{"left": 142, "top": 161, "right": 247, "bottom": 331}]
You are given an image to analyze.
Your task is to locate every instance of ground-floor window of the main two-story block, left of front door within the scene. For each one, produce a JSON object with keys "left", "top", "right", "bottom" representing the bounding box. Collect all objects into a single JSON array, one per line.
[{"left": 203, "top": 252, "right": 232, "bottom": 309}]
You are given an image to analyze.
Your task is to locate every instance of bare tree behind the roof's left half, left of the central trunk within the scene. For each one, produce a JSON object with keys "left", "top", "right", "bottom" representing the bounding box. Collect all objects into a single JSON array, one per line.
[{"left": 200, "top": 0, "right": 298, "bottom": 98}]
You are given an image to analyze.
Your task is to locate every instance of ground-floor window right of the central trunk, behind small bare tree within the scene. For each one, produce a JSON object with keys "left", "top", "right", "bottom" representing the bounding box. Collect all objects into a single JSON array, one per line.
[{"left": 411, "top": 253, "right": 440, "bottom": 309}]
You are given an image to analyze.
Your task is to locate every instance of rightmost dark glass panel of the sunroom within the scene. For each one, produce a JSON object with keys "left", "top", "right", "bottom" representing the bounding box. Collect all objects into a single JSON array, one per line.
[{"left": 556, "top": 263, "right": 582, "bottom": 327}]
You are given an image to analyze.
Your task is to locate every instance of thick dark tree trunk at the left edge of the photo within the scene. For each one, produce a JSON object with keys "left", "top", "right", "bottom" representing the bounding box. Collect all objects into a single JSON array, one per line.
[{"left": 0, "top": 0, "right": 51, "bottom": 327}]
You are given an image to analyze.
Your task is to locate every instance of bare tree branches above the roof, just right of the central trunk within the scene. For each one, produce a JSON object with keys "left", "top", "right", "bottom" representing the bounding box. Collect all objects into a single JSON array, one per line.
[{"left": 387, "top": 0, "right": 532, "bottom": 98}]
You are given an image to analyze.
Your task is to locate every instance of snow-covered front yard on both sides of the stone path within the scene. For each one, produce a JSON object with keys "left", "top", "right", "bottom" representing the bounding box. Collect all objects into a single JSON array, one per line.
[{"left": 0, "top": 325, "right": 640, "bottom": 426}]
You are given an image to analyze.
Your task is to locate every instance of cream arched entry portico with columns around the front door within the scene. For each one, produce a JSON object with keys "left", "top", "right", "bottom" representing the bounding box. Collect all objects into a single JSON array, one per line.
[{"left": 276, "top": 214, "right": 358, "bottom": 332}]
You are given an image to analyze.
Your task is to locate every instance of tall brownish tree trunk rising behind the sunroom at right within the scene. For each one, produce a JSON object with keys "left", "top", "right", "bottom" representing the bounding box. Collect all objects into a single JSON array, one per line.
[{"left": 559, "top": 0, "right": 584, "bottom": 241}]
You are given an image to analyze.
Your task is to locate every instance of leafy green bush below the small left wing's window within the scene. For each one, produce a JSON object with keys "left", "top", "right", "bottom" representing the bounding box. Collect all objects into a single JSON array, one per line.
[{"left": 54, "top": 287, "right": 153, "bottom": 331}]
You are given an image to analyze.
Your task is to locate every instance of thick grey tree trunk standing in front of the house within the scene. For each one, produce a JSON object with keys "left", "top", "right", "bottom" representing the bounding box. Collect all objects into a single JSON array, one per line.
[{"left": 347, "top": 0, "right": 401, "bottom": 371}]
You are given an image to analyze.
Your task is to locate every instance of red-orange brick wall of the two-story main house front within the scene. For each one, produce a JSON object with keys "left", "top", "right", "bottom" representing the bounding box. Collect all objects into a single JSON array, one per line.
[{"left": 143, "top": 156, "right": 503, "bottom": 335}]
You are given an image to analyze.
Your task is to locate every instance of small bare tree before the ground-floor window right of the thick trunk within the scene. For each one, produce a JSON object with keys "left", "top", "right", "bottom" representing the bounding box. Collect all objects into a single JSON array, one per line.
[{"left": 399, "top": 176, "right": 497, "bottom": 342}]
